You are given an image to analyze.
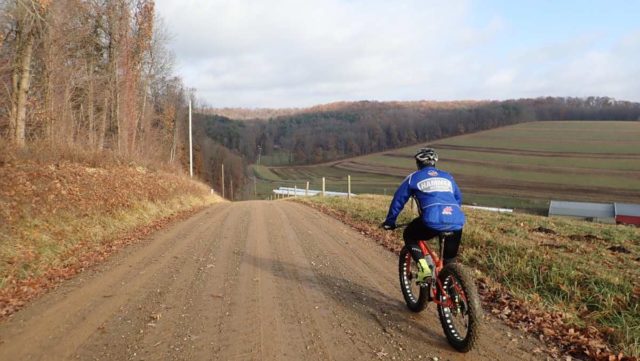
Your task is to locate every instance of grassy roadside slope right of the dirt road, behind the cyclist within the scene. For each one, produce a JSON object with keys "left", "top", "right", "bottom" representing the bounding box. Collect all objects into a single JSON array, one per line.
[{"left": 300, "top": 195, "right": 640, "bottom": 356}]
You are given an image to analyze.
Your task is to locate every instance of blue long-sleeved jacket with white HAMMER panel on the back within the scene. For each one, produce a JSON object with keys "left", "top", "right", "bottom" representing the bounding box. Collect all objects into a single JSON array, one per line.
[{"left": 385, "top": 167, "right": 465, "bottom": 231}]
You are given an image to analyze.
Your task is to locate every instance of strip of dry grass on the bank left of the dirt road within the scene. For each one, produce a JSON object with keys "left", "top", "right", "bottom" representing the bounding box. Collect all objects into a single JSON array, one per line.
[{"left": 0, "top": 195, "right": 216, "bottom": 289}]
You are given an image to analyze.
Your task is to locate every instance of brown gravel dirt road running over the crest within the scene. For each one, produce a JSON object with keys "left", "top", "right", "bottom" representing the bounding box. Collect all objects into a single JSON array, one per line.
[{"left": 0, "top": 201, "right": 544, "bottom": 361}]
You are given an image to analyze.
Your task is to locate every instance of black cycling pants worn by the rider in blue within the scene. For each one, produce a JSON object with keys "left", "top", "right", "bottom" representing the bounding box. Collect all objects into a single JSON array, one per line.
[{"left": 402, "top": 217, "right": 462, "bottom": 264}]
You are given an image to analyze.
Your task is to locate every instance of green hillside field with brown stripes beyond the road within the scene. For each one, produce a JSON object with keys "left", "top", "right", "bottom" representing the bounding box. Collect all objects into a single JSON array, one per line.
[{"left": 255, "top": 121, "right": 640, "bottom": 213}]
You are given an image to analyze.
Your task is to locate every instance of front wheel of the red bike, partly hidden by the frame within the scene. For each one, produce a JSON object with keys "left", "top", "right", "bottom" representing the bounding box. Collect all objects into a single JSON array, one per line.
[{"left": 398, "top": 246, "right": 429, "bottom": 312}]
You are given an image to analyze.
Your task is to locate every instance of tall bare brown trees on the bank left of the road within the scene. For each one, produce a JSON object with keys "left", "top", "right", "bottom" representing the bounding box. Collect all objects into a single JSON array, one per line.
[{"left": 0, "top": 0, "right": 189, "bottom": 164}]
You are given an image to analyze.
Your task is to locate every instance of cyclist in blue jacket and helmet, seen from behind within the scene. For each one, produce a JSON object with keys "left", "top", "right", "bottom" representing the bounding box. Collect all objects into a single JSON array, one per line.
[{"left": 381, "top": 148, "right": 465, "bottom": 283}]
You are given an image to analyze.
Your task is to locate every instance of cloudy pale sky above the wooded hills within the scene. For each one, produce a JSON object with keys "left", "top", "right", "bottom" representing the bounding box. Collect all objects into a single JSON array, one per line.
[{"left": 156, "top": 0, "right": 640, "bottom": 108}]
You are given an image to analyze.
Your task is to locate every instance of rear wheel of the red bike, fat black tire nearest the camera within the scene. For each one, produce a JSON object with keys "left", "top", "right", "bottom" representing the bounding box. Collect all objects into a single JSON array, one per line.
[{"left": 437, "top": 263, "right": 482, "bottom": 352}]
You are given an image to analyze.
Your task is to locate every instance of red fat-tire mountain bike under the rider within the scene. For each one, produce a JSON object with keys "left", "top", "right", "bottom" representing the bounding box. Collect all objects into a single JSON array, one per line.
[{"left": 399, "top": 232, "right": 482, "bottom": 352}]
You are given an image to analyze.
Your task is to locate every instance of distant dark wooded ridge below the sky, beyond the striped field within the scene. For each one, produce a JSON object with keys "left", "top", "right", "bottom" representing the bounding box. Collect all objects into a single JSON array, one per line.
[{"left": 196, "top": 97, "right": 640, "bottom": 164}]
